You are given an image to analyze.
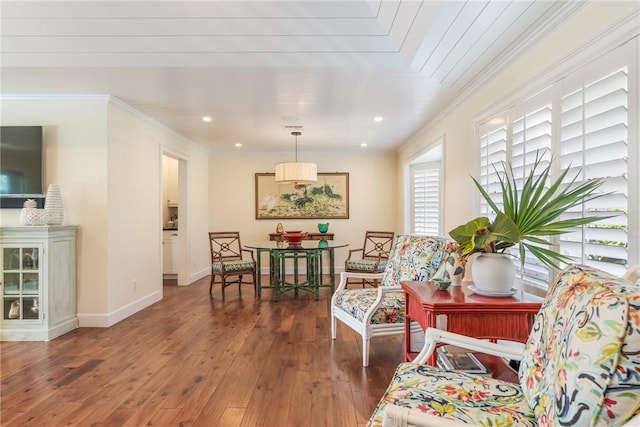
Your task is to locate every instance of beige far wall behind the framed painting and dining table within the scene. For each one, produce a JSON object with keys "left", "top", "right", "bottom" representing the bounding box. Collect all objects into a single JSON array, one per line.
[{"left": 209, "top": 150, "right": 399, "bottom": 271}]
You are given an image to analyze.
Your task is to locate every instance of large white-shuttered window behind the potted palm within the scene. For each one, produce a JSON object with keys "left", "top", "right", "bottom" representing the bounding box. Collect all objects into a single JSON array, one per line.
[{"left": 478, "top": 43, "right": 638, "bottom": 286}]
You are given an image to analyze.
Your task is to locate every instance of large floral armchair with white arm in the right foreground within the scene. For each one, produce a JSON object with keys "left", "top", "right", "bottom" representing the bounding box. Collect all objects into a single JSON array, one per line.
[{"left": 368, "top": 265, "right": 640, "bottom": 427}]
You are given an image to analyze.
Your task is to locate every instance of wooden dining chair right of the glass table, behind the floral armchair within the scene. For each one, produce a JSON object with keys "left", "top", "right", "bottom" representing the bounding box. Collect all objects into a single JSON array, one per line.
[{"left": 344, "top": 231, "right": 395, "bottom": 288}]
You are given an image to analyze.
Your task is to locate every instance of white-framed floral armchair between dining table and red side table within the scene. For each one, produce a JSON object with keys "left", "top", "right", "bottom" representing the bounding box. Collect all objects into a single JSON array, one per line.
[{"left": 331, "top": 235, "right": 457, "bottom": 366}]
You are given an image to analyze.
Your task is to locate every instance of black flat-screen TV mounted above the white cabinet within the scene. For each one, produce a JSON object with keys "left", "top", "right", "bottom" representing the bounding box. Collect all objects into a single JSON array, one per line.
[{"left": 0, "top": 126, "right": 44, "bottom": 208}]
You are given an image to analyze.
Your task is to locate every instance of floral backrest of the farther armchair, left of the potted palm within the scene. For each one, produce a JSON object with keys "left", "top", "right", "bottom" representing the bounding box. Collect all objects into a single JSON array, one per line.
[{"left": 381, "top": 235, "right": 447, "bottom": 286}]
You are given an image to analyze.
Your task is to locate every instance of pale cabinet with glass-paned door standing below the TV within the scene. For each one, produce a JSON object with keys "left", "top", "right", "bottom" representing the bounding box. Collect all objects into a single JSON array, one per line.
[{"left": 0, "top": 226, "right": 78, "bottom": 341}]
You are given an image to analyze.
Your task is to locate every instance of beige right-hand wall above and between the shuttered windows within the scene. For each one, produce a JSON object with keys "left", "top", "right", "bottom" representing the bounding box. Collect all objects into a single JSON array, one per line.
[{"left": 398, "top": 1, "right": 638, "bottom": 239}]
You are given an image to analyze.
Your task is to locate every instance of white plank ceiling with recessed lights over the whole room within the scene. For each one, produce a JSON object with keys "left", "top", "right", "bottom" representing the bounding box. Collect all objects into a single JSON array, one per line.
[{"left": 0, "top": 0, "right": 583, "bottom": 151}]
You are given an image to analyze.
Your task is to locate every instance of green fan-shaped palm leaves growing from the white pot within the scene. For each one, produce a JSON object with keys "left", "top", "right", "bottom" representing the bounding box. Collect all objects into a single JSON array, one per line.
[{"left": 449, "top": 153, "right": 608, "bottom": 268}]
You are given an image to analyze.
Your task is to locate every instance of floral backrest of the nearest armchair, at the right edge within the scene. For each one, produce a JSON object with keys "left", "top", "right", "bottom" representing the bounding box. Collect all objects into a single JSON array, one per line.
[{"left": 519, "top": 265, "right": 640, "bottom": 426}]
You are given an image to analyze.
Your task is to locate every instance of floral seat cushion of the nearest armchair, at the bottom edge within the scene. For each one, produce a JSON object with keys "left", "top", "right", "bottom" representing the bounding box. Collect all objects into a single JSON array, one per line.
[{"left": 367, "top": 363, "right": 537, "bottom": 427}]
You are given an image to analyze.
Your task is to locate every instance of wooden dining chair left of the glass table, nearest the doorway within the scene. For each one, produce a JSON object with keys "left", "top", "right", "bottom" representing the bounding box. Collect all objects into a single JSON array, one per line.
[{"left": 209, "top": 231, "right": 257, "bottom": 298}]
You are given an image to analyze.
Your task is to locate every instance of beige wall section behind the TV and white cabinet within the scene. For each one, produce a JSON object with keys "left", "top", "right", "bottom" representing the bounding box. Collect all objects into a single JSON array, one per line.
[{"left": 0, "top": 98, "right": 109, "bottom": 313}]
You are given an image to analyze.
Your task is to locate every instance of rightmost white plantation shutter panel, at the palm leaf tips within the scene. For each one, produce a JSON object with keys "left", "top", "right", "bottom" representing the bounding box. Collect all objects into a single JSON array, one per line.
[{"left": 560, "top": 67, "right": 629, "bottom": 275}]
